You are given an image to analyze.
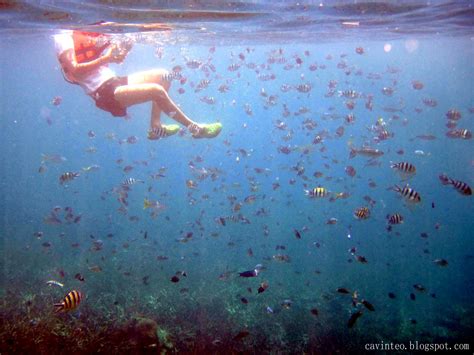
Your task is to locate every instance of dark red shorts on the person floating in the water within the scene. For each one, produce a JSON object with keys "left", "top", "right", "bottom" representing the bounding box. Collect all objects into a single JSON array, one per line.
[{"left": 92, "top": 76, "right": 128, "bottom": 117}]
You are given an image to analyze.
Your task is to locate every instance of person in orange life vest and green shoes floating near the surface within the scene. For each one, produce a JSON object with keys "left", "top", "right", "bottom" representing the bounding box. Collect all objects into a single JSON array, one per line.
[{"left": 54, "top": 26, "right": 222, "bottom": 140}]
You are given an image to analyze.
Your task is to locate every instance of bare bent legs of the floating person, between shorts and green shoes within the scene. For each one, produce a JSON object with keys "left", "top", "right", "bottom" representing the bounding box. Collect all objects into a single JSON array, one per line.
[{"left": 115, "top": 69, "right": 196, "bottom": 128}]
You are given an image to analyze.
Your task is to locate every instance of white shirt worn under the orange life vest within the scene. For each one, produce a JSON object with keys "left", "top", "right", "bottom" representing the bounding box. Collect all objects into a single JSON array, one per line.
[{"left": 54, "top": 30, "right": 115, "bottom": 95}]
